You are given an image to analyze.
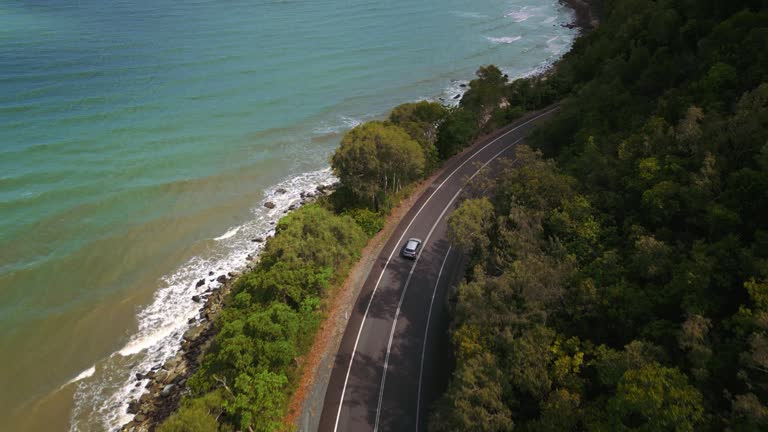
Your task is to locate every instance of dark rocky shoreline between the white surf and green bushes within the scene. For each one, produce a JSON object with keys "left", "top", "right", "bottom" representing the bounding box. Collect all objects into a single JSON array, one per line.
[{"left": 119, "top": 183, "right": 338, "bottom": 432}]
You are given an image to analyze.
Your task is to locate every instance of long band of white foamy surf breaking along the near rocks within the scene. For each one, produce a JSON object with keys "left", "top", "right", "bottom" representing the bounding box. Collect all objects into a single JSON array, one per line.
[{"left": 70, "top": 168, "right": 336, "bottom": 432}]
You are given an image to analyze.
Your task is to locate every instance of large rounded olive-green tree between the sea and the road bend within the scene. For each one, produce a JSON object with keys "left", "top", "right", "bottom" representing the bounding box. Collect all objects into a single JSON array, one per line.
[{"left": 331, "top": 121, "right": 425, "bottom": 210}]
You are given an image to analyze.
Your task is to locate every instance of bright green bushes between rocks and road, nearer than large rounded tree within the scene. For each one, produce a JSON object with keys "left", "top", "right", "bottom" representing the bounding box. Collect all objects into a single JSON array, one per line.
[{"left": 170, "top": 204, "right": 367, "bottom": 432}]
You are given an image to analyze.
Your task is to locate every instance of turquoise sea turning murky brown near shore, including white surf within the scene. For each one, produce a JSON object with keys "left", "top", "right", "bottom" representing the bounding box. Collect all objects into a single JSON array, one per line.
[{"left": 0, "top": 0, "right": 575, "bottom": 431}]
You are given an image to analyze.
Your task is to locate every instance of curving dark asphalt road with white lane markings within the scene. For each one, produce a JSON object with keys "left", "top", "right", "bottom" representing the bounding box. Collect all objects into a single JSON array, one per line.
[{"left": 319, "top": 108, "right": 554, "bottom": 432}]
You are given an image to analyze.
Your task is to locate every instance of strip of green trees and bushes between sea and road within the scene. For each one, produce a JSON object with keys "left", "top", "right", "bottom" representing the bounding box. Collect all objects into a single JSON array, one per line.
[{"left": 158, "top": 60, "right": 510, "bottom": 432}]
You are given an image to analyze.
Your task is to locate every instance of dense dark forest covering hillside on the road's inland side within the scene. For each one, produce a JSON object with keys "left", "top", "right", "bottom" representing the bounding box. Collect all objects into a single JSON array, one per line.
[{"left": 429, "top": 0, "right": 768, "bottom": 432}]
